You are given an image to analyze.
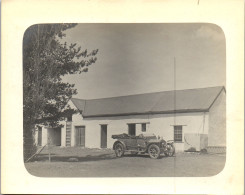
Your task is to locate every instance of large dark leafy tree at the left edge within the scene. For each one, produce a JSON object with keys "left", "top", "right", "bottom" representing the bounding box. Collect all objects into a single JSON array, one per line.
[{"left": 23, "top": 24, "right": 98, "bottom": 159}]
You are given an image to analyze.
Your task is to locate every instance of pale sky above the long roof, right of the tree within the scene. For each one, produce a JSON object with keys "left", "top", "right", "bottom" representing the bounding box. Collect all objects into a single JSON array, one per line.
[{"left": 63, "top": 23, "right": 226, "bottom": 99}]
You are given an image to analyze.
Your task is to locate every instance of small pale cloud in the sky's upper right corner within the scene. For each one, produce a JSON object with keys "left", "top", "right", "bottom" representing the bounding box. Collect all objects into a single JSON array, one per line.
[{"left": 195, "top": 25, "right": 225, "bottom": 41}]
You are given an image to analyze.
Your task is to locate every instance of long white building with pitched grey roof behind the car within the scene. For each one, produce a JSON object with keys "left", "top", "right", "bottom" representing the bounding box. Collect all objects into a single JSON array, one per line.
[{"left": 36, "top": 87, "right": 226, "bottom": 151}]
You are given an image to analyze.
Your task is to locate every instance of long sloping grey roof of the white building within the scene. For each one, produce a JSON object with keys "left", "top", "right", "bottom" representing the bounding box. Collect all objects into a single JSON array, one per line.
[{"left": 72, "top": 86, "right": 224, "bottom": 117}]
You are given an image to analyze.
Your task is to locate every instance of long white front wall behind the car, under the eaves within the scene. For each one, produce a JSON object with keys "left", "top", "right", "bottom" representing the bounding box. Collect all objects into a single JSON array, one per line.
[{"left": 68, "top": 112, "right": 209, "bottom": 151}]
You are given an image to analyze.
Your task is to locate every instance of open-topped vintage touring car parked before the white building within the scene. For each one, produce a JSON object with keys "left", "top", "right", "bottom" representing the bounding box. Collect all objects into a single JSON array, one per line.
[{"left": 112, "top": 133, "right": 175, "bottom": 159}]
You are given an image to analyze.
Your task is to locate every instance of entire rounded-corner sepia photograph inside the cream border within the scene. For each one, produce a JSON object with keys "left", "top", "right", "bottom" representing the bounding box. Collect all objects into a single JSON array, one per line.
[{"left": 23, "top": 23, "right": 228, "bottom": 177}]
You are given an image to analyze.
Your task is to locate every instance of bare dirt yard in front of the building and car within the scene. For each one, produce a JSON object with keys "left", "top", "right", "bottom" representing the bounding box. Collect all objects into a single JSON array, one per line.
[{"left": 25, "top": 147, "right": 226, "bottom": 177}]
